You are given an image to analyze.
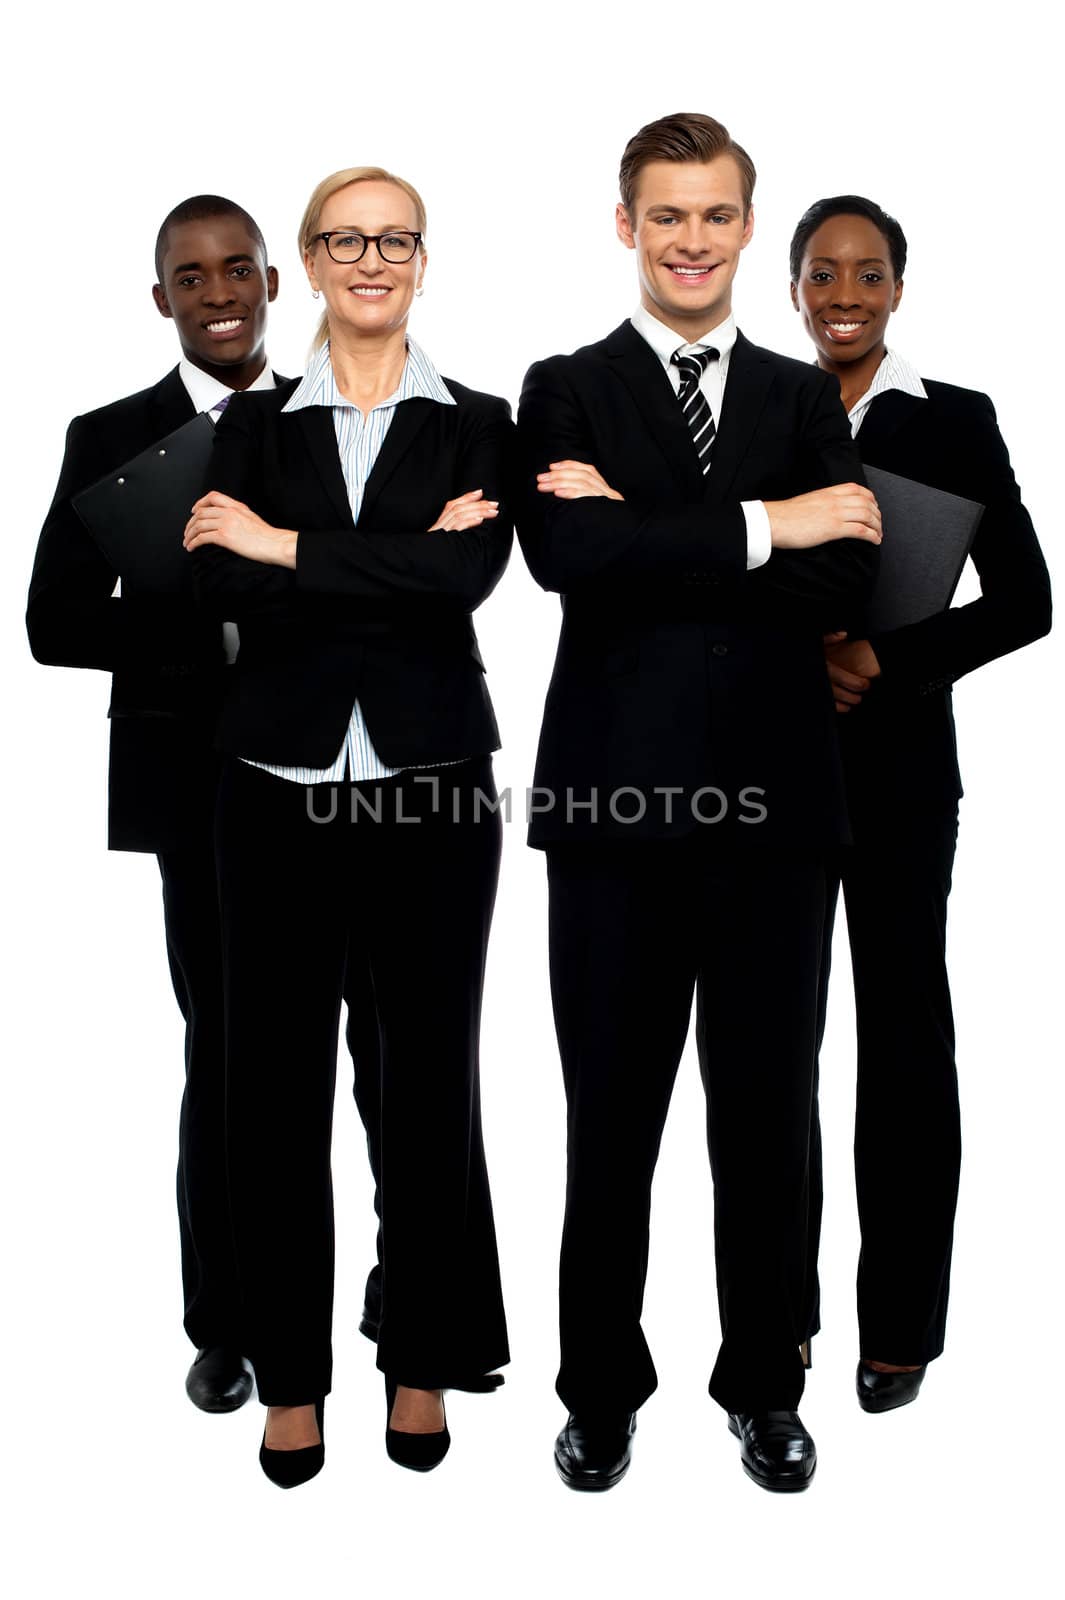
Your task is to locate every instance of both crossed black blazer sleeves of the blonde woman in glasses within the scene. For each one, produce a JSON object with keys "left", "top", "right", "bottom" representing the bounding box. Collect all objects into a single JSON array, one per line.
[{"left": 193, "top": 400, "right": 513, "bottom": 621}]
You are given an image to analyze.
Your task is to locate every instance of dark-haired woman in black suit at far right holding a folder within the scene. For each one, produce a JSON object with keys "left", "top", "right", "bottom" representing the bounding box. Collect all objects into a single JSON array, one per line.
[{"left": 790, "top": 195, "right": 1051, "bottom": 1411}]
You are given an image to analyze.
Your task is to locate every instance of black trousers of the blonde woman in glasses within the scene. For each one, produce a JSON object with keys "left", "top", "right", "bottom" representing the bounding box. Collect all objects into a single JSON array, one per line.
[{"left": 216, "top": 758, "right": 509, "bottom": 1405}]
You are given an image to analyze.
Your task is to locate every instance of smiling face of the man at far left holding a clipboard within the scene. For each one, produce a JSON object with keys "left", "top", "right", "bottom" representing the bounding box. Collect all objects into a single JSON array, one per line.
[{"left": 152, "top": 216, "right": 277, "bottom": 389}]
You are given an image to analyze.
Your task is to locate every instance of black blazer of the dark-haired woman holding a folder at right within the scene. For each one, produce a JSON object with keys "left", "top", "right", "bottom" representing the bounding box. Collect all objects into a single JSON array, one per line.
[{"left": 838, "top": 379, "right": 1051, "bottom": 826}]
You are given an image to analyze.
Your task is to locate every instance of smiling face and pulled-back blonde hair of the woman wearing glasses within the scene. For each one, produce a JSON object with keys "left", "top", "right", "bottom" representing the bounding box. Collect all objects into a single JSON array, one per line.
[{"left": 304, "top": 179, "right": 427, "bottom": 339}]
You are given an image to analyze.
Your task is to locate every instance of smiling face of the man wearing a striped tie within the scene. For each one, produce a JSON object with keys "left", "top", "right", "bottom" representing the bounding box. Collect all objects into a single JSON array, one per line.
[{"left": 617, "top": 155, "right": 755, "bottom": 342}]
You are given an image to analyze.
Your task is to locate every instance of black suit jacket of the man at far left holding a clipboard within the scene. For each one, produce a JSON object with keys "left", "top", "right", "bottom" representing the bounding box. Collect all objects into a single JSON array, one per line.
[{"left": 26, "top": 366, "right": 249, "bottom": 851}]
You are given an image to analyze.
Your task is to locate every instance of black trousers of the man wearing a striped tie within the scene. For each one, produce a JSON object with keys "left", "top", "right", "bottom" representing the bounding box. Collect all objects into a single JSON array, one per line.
[{"left": 547, "top": 830, "right": 825, "bottom": 1414}]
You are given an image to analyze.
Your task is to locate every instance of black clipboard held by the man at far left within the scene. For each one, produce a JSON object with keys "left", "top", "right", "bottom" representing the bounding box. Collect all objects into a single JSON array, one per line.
[{"left": 74, "top": 411, "right": 214, "bottom": 594}]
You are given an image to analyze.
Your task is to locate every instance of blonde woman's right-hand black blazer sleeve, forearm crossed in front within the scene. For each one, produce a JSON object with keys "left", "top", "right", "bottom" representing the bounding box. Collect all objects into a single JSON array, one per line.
[{"left": 296, "top": 400, "right": 513, "bottom": 611}]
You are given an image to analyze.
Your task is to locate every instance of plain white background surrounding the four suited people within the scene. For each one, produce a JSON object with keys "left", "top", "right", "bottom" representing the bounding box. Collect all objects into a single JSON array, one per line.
[{"left": 0, "top": 0, "right": 1062, "bottom": 1600}]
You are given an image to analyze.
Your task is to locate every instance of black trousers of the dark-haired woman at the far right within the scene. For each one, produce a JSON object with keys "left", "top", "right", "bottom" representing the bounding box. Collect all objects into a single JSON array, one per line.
[{"left": 808, "top": 803, "right": 961, "bottom": 1366}]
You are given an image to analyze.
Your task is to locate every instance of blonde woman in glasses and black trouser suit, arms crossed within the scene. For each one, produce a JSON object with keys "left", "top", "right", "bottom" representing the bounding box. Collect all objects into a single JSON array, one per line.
[{"left": 185, "top": 168, "right": 512, "bottom": 1486}]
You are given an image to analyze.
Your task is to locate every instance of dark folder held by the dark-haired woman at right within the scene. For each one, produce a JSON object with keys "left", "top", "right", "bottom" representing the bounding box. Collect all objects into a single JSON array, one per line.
[{"left": 865, "top": 467, "right": 983, "bottom": 634}]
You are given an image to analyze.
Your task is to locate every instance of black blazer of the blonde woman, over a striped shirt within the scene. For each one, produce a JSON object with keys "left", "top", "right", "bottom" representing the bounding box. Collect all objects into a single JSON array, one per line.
[{"left": 192, "top": 379, "right": 513, "bottom": 766}]
